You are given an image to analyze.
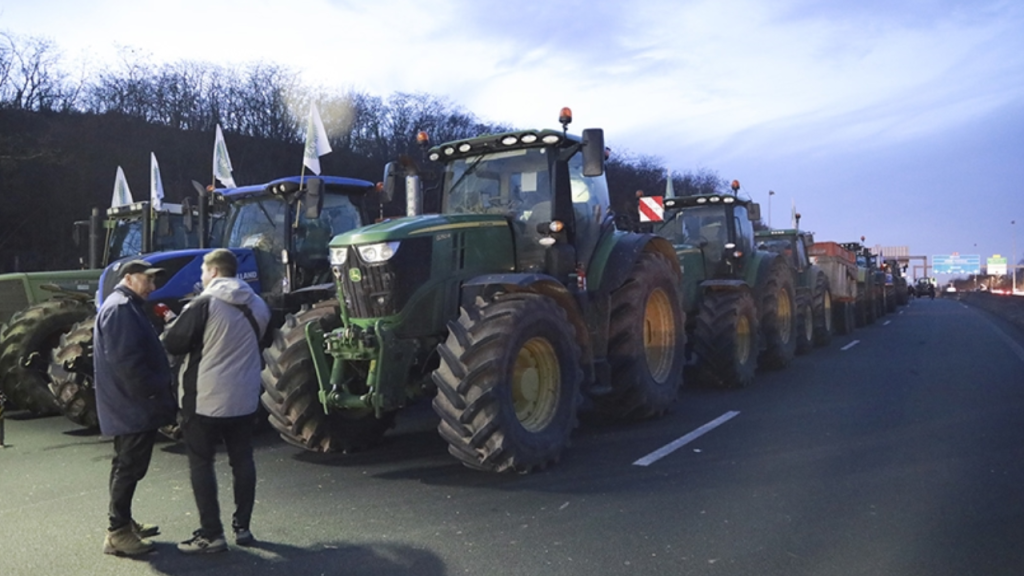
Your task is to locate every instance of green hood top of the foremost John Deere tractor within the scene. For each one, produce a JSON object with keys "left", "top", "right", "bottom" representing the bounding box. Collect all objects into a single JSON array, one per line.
[{"left": 331, "top": 214, "right": 509, "bottom": 248}]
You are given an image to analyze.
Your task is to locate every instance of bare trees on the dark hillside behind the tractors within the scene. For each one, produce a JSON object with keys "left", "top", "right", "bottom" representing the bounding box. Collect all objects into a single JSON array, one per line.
[{"left": 0, "top": 33, "right": 725, "bottom": 272}]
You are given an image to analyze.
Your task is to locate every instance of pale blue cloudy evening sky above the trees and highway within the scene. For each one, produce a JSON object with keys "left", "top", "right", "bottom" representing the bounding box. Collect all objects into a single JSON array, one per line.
[{"left": 0, "top": 0, "right": 1024, "bottom": 274}]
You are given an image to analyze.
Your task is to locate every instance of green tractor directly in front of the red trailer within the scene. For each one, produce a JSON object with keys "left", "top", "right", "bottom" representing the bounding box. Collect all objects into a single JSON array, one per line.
[{"left": 754, "top": 224, "right": 833, "bottom": 354}]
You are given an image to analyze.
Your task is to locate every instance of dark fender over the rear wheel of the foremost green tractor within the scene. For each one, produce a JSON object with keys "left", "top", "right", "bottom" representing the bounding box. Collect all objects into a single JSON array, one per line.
[{"left": 587, "top": 232, "right": 683, "bottom": 294}]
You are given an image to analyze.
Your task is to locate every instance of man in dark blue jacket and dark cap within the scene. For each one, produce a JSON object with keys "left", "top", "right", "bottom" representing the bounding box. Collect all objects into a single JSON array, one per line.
[{"left": 93, "top": 260, "right": 177, "bottom": 556}]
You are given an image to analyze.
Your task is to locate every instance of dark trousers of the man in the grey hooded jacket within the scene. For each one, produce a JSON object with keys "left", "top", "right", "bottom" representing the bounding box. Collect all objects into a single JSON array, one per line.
[{"left": 181, "top": 414, "right": 256, "bottom": 538}]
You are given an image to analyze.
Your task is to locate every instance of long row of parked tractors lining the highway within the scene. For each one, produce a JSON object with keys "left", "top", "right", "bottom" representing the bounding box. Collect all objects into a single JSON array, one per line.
[{"left": 0, "top": 109, "right": 905, "bottom": 472}]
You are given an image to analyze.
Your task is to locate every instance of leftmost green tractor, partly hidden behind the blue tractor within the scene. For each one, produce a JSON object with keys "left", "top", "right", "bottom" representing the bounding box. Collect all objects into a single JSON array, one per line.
[{"left": 0, "top": 196, "right": 205, "bottom": 414}]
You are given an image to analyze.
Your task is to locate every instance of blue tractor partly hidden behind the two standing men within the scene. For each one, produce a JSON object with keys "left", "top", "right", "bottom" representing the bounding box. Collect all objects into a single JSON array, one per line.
[{"left": 49, "top": 176, "right": 388, "bottom": 427}]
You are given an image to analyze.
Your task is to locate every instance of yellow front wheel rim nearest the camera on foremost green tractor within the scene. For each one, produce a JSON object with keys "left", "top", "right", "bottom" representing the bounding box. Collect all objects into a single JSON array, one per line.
[{"left": 512, "top": 337, "right": 562, "bottom": 431}]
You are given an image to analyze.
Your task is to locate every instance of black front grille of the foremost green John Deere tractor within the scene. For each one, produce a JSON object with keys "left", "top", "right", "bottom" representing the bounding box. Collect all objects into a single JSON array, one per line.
[{"left": 341, "top": 238, "right": 432, "bottom": 318}]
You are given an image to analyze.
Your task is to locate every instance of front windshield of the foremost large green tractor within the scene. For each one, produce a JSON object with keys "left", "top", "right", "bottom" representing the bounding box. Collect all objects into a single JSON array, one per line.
[{"left": 441, "top": 148, "right": 551, "bottom": 220}]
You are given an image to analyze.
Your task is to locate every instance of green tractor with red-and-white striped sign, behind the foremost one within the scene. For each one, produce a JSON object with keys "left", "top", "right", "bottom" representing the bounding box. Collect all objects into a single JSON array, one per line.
[{"left": 641, "top": 180, "right": 797, "bottom": 387}]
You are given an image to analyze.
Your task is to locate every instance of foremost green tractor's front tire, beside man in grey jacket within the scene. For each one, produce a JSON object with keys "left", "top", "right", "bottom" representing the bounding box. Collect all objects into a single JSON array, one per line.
[{"left": 260, "top": 300, "right": 394, "bottom": 452}]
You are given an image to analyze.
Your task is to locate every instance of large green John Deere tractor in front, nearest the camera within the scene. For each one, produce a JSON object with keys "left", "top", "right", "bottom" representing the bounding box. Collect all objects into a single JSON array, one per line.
[{"left": 262, "top": 109, "right": 685, "bottom": 474}]
